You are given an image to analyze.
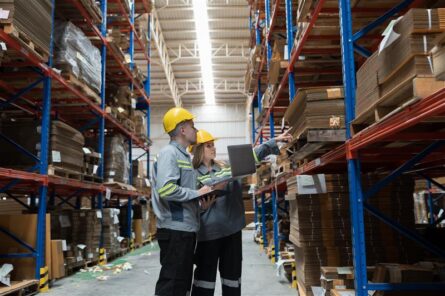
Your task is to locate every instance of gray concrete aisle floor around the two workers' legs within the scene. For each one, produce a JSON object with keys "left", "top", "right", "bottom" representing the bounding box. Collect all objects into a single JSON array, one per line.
[{"left": 48, "top": 231, "right": 297, "bottom": 296}]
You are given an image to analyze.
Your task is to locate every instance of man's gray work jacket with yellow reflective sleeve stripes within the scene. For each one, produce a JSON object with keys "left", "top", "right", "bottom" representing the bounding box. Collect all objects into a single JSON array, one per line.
[{"left": 151, "top": 141, "right": 200, "bottom": 232}]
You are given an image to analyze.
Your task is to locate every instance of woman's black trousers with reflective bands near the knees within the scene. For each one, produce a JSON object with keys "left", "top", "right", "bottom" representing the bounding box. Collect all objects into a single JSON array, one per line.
[{"left": 192, "top": 231, "right": 243, "bottom": 296}]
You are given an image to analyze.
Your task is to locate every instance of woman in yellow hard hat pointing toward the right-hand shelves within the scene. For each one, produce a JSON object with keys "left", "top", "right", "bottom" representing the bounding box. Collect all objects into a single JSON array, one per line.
[{"left": 191, "top": 130, "right": 292, "bottom": 296}]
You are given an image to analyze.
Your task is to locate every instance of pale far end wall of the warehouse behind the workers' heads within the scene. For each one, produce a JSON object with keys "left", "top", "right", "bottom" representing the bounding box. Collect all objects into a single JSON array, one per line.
[{"left": 134, "top": 104, "right": 249, "bottom": 170}]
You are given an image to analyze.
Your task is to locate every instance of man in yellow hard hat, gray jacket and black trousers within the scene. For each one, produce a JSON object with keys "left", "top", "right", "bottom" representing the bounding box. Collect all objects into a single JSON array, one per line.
[{"left": 152, "top": 107, "right": 211, "bottom": 296}]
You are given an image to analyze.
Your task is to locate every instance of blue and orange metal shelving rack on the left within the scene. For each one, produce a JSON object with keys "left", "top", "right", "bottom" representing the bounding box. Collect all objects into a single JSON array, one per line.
[{"left": 0, "top": 0, "right": 151, "bottom": 289}]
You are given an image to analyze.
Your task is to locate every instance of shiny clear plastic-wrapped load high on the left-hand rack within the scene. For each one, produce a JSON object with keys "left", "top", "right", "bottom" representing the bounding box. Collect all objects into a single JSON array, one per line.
[{"left": 54, "top": 22, "right": 102, "bottom": 92}]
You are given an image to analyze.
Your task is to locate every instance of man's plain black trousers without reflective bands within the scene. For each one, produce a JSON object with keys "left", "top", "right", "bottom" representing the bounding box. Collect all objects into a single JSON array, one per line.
[{"left": 155, "top": 229, "right": 196, "bottom": 296}]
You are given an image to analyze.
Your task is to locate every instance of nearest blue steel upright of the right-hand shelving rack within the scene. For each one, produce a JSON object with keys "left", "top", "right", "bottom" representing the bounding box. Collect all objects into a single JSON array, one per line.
[{"left": 339, "top": 0, "right": 368, "bottom": 296}]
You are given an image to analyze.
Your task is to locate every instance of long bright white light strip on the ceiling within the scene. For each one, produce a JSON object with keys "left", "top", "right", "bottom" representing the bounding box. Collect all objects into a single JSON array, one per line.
[{"left": 193, "top": 0, "right": 215, "bottom": 104}]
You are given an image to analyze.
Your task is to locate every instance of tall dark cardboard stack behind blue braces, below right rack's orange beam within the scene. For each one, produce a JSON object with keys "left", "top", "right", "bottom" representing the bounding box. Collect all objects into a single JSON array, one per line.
[{"left": 287, "top": 175, "right": 422, "bottom": 295}]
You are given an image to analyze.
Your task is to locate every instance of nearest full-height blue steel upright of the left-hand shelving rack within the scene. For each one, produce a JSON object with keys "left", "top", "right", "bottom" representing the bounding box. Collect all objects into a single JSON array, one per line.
[{"left": 35, "top": 0, "right": 55, "bottom": 279}]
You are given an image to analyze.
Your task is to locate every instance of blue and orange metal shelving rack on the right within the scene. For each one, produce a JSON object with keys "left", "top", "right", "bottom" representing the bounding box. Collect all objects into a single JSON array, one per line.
[{"left": 246, "top": 0, "right": 445, "bottom": 296}]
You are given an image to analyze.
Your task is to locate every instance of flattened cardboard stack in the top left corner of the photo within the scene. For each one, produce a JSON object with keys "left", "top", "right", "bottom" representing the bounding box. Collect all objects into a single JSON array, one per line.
[{"left": 0, "top": 0, "right": 52, "bottom": 57}]
